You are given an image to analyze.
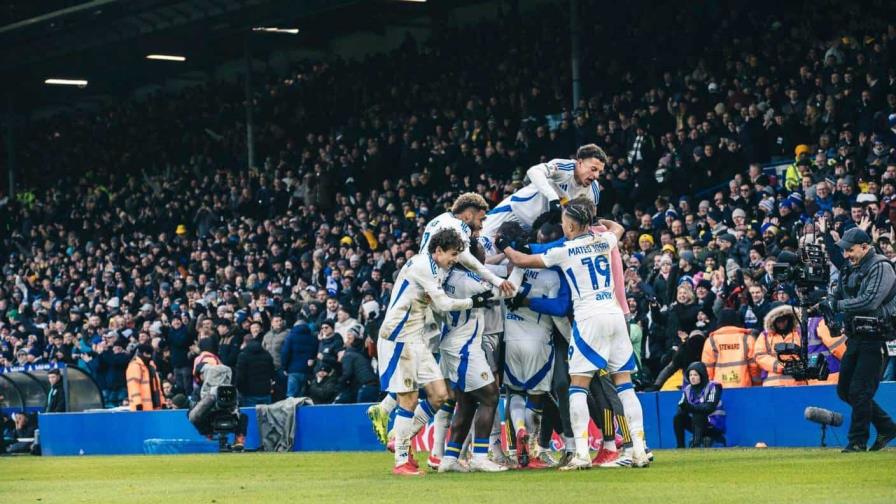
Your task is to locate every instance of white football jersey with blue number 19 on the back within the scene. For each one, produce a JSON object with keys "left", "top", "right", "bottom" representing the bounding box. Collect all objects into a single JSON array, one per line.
[{"left": 542, "top": 232, "right": 622, "bottom": 320}]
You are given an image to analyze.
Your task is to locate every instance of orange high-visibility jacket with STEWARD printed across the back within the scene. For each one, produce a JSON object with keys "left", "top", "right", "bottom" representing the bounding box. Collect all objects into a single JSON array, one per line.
[{"left": 701, "top": 326, "right": 760, "bottom": 388}]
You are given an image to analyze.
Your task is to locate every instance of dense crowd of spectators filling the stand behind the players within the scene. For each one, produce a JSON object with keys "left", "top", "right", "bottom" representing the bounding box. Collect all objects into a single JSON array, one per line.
[{"left": 0, "top": 1, "right": 896, "bottom": 406}]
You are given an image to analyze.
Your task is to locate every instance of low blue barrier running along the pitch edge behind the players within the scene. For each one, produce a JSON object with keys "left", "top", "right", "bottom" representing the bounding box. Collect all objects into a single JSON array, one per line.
[{"left": 39, "top": 383, "right": 896, "bottom": 455}]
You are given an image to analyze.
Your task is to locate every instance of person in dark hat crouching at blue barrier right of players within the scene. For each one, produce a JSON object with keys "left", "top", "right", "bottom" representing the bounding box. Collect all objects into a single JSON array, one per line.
[{"left": 672, "top": 362, "right": 725, "bottom": 448}]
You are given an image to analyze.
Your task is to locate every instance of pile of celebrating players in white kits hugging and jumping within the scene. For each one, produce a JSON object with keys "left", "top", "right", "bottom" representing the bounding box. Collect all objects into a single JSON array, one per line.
[{"left": 368, "top": 145, "right": 649, "bottom": 476}]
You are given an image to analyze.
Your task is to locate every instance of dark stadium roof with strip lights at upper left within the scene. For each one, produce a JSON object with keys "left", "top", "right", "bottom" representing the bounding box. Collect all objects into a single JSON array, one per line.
[{"left": 0, "top": 0, "right": 475, "bottom": 113}]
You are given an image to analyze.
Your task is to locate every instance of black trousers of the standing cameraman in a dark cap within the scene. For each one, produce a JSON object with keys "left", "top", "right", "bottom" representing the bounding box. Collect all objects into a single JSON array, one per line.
[{"left": 837, "top": 338, "right": 896, "bottom": 446}]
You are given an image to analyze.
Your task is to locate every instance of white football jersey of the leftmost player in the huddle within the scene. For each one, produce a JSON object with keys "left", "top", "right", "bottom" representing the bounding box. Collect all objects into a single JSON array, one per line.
[{"left": 379, "top": 254, "right": 473, "bottom": 343}]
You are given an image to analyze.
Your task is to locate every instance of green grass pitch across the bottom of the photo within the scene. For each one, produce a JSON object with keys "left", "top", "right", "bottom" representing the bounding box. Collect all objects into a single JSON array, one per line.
[{"left": 0, "top": 449, "right": 896, "bottom": 504}]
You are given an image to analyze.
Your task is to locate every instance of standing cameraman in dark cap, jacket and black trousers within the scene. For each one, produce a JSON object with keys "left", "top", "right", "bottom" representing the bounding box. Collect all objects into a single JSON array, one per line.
[{"left": 822, "top": 228, "right": 896, "bottom": 452}]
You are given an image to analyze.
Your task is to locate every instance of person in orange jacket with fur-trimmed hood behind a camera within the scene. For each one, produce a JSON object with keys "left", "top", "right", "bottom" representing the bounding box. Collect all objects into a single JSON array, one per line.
[{"left": 755, "top": 305, "right": 808, "bottom": 387}]
